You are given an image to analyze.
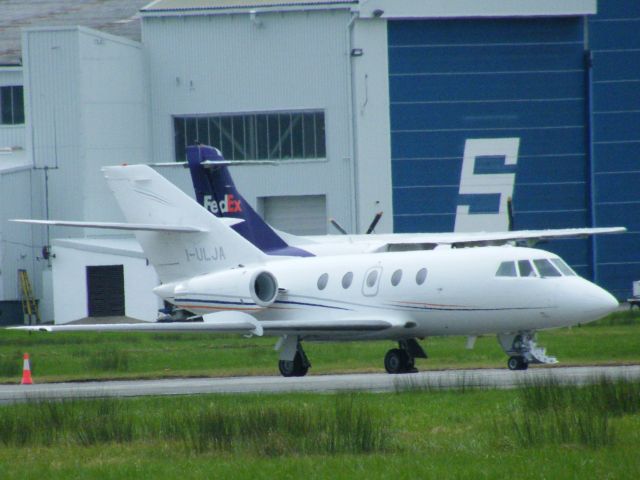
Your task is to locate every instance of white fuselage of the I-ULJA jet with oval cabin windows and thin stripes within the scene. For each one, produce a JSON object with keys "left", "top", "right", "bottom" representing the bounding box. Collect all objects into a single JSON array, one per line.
[{"left": 156, "top": 246, "right": 617, "bottom": 339}]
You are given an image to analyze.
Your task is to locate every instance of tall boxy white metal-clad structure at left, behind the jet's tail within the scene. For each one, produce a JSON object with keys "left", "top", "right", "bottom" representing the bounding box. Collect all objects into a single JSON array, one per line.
[{"left": 23, "top": 28, "right": 149, "bottom": 226}]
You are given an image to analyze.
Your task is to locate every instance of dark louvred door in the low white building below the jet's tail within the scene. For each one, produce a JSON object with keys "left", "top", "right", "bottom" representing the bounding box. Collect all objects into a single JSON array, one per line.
[{"left": 87, "top": 265, "right": 124, "bottom": 317}]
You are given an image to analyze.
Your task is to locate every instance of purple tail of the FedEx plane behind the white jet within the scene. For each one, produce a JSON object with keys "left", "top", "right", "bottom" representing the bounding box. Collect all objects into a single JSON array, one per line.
[{"left": 187, "top": 145, "right": 313, "bottom": 257}]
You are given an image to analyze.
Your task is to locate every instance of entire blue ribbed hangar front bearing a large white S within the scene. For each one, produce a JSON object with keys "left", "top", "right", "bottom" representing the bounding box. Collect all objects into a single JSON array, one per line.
[{"left": 388, "top": 0, "right": 640, "bottom": 298}]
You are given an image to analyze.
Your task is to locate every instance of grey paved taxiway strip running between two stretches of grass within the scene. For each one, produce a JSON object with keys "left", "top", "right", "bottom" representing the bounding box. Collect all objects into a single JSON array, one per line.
[{"left": 0, "top": 365, "right": 640, "bottom": 403}]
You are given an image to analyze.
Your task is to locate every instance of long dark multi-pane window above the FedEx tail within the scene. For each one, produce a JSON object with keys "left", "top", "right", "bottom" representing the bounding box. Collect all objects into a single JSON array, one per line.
[{"left": 173, "top": 111, "right": 327, "bottom": 162}]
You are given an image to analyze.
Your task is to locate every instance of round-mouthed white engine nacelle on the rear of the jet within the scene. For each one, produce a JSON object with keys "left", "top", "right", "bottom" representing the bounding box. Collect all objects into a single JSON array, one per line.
[{"left": 171, "top": 268, "right": 278, "bottom": 309}]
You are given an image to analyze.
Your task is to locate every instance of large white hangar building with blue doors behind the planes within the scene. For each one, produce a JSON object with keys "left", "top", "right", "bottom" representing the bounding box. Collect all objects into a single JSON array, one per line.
[{"left": 0, "top": 0, "right": 640, "bottom": 323}]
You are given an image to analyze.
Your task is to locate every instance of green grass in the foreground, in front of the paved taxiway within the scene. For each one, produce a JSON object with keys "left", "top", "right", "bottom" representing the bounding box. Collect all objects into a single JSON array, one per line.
[{"left": 0, "top": 383, "right": 640, "bottom": 479}]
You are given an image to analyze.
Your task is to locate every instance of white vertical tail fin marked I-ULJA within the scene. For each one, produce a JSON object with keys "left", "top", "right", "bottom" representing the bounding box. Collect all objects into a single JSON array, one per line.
[{"left": 102, "top": 165, "right": 266, "bottom": 283}]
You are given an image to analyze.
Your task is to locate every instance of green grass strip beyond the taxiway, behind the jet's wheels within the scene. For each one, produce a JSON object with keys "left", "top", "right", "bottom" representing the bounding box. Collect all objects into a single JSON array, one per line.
[{"left": 0, "top": 311, "right": 640, "bottom": 383}]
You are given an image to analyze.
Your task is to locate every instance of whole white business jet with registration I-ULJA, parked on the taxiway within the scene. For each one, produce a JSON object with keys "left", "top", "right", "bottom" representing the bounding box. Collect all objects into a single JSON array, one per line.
[{"left": 11, "top": 165, "right": 624, "bottom": 376}]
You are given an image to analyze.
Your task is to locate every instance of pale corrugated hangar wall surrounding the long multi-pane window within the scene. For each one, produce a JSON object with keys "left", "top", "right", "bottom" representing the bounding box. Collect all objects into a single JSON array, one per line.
[{"left": 143, "top": 10, "right": 354, "bottom": 228}]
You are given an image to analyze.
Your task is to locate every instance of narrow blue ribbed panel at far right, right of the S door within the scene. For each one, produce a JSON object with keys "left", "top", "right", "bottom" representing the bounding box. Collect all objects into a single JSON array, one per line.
[{"left": 589, "top": 0, "right": 640, "bottom": 298}]
